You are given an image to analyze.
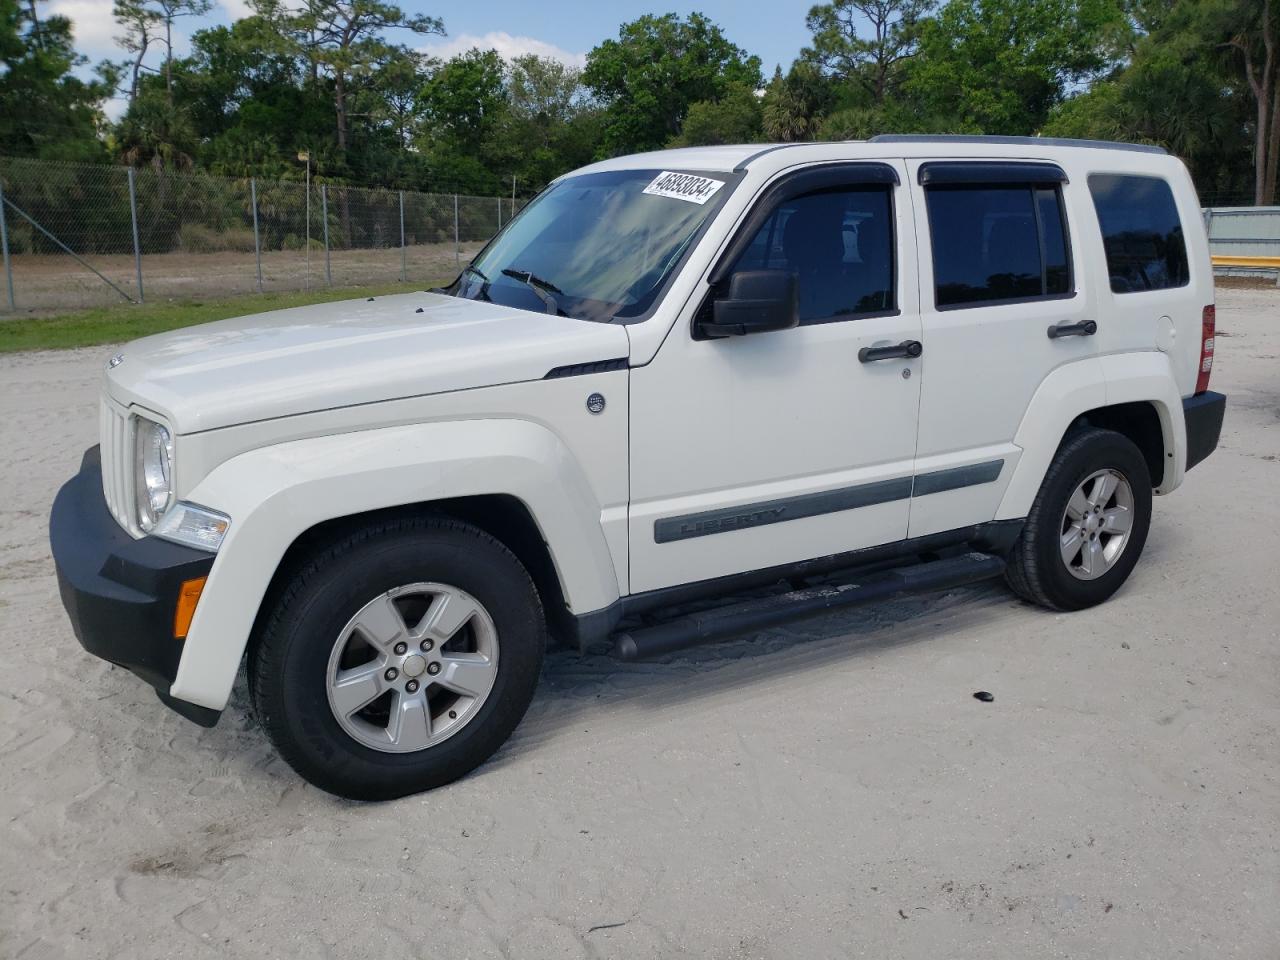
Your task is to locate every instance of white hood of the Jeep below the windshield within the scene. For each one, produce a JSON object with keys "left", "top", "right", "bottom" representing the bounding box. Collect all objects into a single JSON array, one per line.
[{"left": 106, "top": 293, "right": 627, "bottom": 434}]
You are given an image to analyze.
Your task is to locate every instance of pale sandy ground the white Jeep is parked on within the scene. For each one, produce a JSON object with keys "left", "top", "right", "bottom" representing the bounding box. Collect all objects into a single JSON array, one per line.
[{"left": 0, "top": 289, "right": 1280, "bottom": 960}]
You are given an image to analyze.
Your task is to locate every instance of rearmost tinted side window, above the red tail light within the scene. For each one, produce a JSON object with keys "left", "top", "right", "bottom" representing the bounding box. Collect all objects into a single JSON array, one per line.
[{"left": 1089, "top": 174, "right": 1190, "bottom": 293}]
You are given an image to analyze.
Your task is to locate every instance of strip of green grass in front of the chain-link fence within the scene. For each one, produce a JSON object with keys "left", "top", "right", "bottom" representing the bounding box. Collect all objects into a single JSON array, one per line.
[{"left": 0, "top": 283, "right": 450, "bottom": 353}]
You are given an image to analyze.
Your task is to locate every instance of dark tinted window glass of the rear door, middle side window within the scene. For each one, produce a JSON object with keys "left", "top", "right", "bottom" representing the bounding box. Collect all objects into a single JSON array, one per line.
[{"left": 925, "top": 184, "right": 1073, "bottom": 308}]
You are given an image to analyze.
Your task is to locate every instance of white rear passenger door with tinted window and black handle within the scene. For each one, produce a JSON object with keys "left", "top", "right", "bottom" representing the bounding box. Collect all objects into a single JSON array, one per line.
[{"left": 909, "top": 160, "right": 1096, "bottom": 536}]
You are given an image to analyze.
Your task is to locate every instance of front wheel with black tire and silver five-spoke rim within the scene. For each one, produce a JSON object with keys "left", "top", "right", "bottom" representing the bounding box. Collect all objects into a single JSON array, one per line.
[{"left": 248, "top": 517, "right": 547, "bottom": 800}]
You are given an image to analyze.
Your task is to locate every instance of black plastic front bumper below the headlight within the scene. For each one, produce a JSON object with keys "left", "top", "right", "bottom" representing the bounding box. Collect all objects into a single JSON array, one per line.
[{"left": 49, "top": 447, "right": 221, "bottom": 727}]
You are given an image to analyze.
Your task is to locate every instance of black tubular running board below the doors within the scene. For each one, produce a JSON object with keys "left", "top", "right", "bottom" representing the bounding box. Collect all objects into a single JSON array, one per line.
[{"left": 612, "top": 553, "right": 1005, "bottom": 660}]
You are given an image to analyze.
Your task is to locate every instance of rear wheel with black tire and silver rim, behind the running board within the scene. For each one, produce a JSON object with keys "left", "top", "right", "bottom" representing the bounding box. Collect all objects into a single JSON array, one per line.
[{"left": 1005, "top": 428, "right": 1151, "bottom": 611}]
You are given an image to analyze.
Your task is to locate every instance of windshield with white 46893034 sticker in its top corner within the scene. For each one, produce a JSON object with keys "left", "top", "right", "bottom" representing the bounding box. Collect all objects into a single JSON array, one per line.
[{"left": 449, "top": 170, "right": 731, "bottom": 321}]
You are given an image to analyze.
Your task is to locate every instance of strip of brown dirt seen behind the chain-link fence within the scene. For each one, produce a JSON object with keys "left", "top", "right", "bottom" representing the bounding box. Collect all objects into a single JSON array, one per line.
[{"left": 0, "top": 242, "right": 483, "bottom": 317}]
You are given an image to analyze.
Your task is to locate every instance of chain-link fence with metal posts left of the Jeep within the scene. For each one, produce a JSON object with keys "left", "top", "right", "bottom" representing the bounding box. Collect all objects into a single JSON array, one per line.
[{"left": 0, "top": 157, "right": 522, "bottom": 314}]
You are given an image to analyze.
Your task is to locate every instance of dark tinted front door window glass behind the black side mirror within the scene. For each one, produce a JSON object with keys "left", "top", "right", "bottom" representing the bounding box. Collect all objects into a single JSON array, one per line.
[{"left": 732, "top": 186, "right": 896, "bottom": 324}]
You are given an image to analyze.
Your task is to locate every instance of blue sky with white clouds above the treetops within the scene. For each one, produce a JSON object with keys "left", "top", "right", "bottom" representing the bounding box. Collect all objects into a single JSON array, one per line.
[{"left": 45, "top": 0, "right": 812, "bottom": 114}]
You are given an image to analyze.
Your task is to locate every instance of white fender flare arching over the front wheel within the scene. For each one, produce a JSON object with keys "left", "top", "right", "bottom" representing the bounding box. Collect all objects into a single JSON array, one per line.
[{"left": 170, "top": 419, "right": 620, "bottom": 709}]
